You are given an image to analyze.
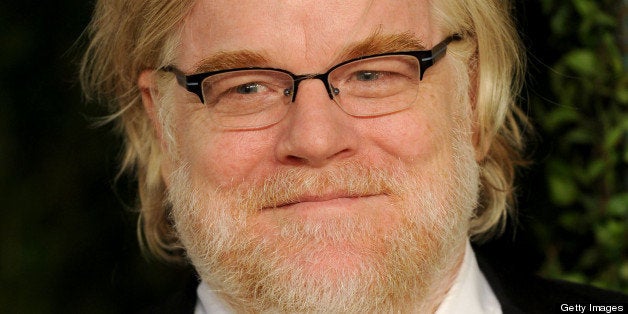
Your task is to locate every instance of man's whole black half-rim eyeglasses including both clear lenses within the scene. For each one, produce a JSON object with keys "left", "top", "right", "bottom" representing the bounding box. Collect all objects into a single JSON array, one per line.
[{"left": 161, "top": 35, "right": 461, "bottom": 129}]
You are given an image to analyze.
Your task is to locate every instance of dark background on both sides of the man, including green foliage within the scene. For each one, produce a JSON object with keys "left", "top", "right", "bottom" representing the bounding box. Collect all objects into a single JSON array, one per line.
[{"left": 0, "top": 0, "right": 628, "bottom": 313}]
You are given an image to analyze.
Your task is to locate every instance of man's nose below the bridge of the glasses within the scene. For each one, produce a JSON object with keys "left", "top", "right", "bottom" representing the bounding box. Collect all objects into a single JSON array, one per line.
[{"left": 276, "top": 80, "right": 359, "bottom": 167}]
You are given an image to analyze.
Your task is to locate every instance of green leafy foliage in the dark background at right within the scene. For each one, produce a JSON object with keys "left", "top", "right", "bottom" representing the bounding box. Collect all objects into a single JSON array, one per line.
[{"left": 529, "top": 0, "right": 628, "bottom": 292}]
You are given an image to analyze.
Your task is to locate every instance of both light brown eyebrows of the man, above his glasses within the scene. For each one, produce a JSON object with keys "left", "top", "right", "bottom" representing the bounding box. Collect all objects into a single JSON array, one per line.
[{"left": 193, "top": 31, "right": 425, "bottom": 73}]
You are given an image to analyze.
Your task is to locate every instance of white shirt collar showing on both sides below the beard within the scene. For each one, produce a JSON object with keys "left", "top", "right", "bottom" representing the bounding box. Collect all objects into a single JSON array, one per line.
[{"left": 194, "top": 242, "right": 502, "bottom": 314}]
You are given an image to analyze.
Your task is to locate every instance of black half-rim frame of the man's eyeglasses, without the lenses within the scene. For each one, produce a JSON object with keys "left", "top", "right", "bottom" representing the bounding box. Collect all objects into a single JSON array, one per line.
[{"left": 160, "top": 34, "right": 462, "bottom": 103}]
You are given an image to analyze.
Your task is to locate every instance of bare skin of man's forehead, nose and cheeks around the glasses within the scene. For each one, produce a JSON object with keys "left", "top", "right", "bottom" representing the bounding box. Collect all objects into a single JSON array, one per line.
[{"left": 149, "top": 1, "right": 453, "bottom": 199}]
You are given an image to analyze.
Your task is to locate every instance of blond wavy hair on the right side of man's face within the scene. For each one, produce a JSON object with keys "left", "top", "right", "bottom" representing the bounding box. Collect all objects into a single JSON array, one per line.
[{"left": 431, "top": 0, "right": 530, "bottom": 241}]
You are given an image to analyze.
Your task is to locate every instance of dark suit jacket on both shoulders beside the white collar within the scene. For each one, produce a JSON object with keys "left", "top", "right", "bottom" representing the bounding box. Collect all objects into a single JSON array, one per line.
[{"left": 146, "top": 250, "right": 628, "bottom": 314}]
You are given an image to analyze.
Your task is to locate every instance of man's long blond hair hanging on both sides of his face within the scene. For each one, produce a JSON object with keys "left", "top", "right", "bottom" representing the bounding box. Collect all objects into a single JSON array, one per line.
[{"left": 81, "top": 0, "right": 525, "bottom": 259}]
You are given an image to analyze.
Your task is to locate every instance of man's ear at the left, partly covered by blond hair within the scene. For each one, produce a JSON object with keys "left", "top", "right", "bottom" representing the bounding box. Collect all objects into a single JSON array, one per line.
[{"left": 137, "top": 70, "right": 173, "bottom": 187}]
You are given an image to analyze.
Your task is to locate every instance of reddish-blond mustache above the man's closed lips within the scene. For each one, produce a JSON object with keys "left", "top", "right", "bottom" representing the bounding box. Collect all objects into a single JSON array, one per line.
[{"left": 213, "top": 162, "right": 407, "bottom": 211}]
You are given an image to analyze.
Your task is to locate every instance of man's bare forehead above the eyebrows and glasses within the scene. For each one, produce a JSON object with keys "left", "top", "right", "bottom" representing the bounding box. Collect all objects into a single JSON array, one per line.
[{"left": 177, "top": 0, "right": 441, "bottom": 72}]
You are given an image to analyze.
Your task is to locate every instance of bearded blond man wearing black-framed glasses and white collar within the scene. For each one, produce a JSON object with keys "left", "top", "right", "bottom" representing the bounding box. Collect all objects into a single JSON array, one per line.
[{"left": 82, "top": 0, "right": 619, "bottom": 313}]
